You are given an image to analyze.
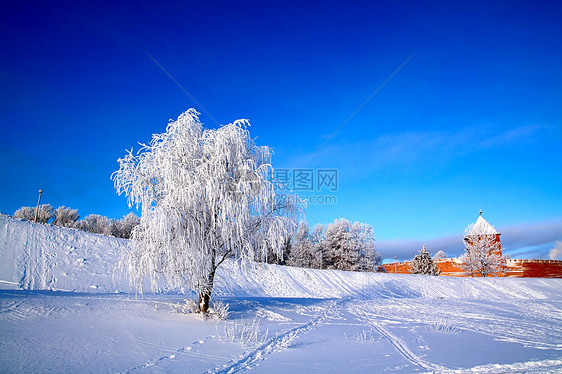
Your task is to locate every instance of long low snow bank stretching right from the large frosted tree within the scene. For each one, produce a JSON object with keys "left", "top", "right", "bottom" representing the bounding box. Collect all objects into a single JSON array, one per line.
[{"left": 214, "top": 262, "right": 562, "bottom": 300}]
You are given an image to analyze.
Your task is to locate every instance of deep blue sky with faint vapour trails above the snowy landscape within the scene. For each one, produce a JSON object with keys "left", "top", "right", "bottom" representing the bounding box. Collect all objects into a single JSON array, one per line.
[{"left": 0, "top": 1, "right": 562, "bottom": 259}]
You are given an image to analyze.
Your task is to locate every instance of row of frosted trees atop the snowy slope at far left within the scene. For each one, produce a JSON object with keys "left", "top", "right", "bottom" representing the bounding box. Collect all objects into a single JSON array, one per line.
[{"left": 14, "top": 204, "right": 140, "bottom": 239}]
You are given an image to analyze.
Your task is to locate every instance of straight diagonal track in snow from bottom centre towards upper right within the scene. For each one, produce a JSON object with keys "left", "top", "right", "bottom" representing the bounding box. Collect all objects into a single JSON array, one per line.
[{"left": 207, "top": 300, "right": 342, "bottom": 374}]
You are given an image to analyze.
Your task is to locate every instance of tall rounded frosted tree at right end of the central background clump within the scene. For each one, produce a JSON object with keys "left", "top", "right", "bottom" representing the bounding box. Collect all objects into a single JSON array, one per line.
[{"left": 322, "top": 218, "right": 380, "bottom": 271}]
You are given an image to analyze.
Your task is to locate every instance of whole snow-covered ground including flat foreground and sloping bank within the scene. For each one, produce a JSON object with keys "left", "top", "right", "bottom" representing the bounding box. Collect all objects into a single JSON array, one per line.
[{"left": 0, "top": 217, "right": 562, "bottom": 373}]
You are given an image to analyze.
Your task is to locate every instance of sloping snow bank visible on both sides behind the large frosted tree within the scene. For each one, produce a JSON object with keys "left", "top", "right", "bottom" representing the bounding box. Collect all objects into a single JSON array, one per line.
[{"left": 0, "top": 216, "right": 562, "bottom": 300}]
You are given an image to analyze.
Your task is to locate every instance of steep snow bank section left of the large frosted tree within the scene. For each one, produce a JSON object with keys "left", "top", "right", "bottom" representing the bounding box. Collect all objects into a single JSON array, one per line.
[{"left": 0, "top": 216, "right": 129, "bottom": 293}]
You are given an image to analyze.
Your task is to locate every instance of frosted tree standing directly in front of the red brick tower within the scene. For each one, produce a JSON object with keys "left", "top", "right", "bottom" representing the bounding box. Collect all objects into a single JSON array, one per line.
[{"left": 459, "top": 224, "right": 505, "bottom": 277}]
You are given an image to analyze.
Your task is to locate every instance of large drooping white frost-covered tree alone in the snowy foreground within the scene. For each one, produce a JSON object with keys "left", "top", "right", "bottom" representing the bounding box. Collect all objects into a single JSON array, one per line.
[{"left": 112, "top": 109, "right": 300, "bottom": 313}]
